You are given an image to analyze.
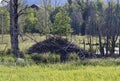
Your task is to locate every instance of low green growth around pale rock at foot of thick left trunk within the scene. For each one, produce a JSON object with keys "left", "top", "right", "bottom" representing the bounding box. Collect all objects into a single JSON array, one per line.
[{"left": 0, "top": 55, "right": 35, "bottom": 67}]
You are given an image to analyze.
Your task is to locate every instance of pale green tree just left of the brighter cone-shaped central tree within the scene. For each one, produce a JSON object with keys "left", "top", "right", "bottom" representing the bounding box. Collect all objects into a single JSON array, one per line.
[{"left": 36, "top": 6, "right": 54, "bottom": 34}]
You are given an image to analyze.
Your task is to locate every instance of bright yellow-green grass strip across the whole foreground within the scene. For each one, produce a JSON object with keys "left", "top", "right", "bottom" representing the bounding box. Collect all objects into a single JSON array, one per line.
[{"left": 0, "top": 64, "right": 120, "bottom": 81}]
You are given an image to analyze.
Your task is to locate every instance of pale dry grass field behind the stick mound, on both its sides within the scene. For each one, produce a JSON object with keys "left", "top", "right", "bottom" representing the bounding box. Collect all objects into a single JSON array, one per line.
[{"left": 0, "top": 34, "right": 96, "bottom": 51}]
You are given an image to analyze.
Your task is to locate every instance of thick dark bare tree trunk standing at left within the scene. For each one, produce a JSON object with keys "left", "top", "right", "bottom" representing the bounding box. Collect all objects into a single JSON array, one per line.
[{"left": 10, "top": 0, "right": 19, "bottom": 57}]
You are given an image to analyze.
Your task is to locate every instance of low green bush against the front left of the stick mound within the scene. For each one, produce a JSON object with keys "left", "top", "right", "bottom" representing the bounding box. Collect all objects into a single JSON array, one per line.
[{"left": 31, "top": 53, "right": 60, "bottom": 64}]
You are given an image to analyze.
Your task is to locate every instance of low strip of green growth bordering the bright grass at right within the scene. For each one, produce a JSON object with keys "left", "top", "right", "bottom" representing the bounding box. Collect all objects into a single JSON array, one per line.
[{"left": 71, "top": 58, "right": 120, "bottom": 66}]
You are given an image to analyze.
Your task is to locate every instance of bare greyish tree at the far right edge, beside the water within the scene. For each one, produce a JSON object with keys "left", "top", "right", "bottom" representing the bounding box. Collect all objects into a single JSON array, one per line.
[{"left": 104, "top": 0, "right": 120, "bottom": 55}]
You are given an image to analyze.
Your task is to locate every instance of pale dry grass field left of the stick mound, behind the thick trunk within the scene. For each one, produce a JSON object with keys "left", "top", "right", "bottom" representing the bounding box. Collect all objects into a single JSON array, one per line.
[{"left": 0, "top": 34, "right": 45, "bottom": 51}]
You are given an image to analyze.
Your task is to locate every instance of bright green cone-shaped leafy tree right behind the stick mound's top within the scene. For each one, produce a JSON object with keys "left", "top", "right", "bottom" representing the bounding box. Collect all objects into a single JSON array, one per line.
[{"left": 51, "top": 9, "right": 72, "bottom": 36}]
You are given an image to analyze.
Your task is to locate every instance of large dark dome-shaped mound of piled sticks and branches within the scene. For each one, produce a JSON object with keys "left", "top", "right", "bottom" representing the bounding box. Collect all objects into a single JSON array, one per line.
[{"left": 28, "top": 37, "right": 89, "bottom": 61}]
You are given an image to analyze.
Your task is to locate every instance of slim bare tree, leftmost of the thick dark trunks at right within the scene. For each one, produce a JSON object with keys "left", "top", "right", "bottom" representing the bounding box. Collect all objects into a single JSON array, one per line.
[{"left": 95, "top": 0, "right": 106, "bottom": 56}]
